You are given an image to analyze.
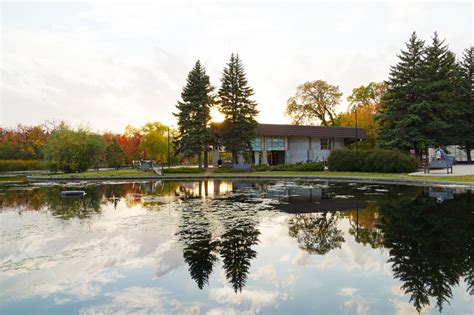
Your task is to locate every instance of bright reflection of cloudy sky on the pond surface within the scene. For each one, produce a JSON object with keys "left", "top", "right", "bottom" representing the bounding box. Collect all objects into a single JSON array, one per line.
[{"left": 0, "top": 181, "right": 473, "bottom": 314}]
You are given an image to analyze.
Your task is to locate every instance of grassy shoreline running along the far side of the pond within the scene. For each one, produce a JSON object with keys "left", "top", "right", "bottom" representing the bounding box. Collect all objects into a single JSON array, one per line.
[{"left": 25, "top": 169, "right": 474, "bottom": 183}]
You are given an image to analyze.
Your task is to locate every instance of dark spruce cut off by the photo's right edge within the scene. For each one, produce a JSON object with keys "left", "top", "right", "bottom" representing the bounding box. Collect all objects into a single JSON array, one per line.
[{"left": 453, "top": 47, "right": 474, "bottom": 162}]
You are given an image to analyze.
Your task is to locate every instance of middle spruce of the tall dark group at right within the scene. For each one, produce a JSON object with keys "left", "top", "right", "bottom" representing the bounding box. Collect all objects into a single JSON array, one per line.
[{"left": 420, "top": 33, "right": 460, "bottom": 145}]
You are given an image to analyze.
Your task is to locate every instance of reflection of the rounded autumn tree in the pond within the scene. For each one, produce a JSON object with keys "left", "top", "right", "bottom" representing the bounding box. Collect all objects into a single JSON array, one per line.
[{"left": 288, "top": 212, "right": 344, "bottom": 255}]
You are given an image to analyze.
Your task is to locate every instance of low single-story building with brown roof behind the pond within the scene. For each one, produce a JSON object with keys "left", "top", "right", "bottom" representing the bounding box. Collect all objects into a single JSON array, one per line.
[{"left": 212, "top": 124, "right": 367, "bottom": 165}]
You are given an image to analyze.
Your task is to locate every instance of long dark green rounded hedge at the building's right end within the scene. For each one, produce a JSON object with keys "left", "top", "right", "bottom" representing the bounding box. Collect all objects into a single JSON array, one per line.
[{"left": 328, "top": 149, "right": 420, "bottom": 173}]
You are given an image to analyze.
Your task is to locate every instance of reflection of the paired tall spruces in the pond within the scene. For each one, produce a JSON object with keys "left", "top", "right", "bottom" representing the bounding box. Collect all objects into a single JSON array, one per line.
[{"left": 177, "top": 198, "right": 260, "bottom": 292}]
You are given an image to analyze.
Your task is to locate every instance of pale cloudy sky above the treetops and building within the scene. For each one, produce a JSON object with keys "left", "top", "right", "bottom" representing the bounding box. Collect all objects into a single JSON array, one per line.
[{"left": 0, "top": 0, "right": 473, "bottom": 132}]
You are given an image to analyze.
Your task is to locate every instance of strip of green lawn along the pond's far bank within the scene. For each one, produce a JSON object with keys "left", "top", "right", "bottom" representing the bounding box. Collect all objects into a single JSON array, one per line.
[{"left": 29, "top": 169, "right": 474, "bottom": 182}]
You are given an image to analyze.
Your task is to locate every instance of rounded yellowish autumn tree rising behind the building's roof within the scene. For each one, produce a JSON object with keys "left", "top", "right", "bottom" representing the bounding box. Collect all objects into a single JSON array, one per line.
[{"left": 286, "top": 80, "right": 342, "bottom": 126}]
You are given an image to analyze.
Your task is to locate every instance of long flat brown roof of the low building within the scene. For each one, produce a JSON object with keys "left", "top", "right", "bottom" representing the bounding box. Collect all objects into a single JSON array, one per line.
[{"left": 255, "top": 124, "right": 367, "bottom": 139}]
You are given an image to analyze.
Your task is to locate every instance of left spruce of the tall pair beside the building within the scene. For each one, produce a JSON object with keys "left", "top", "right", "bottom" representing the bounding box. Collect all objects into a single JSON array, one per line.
[{"left": 173, "top": 60, "right": 213, "bottom": 167}]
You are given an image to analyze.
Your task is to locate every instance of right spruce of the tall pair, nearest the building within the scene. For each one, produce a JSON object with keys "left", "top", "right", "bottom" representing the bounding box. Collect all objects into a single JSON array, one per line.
[{"left": 218, "top": 54, "right": 258, "bottom": 163}]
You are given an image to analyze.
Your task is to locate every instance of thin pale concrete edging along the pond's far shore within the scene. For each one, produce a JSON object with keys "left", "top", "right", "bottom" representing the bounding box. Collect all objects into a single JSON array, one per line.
[{"left": 27, "top": 175, "right": 474, "bottom": 187}]
